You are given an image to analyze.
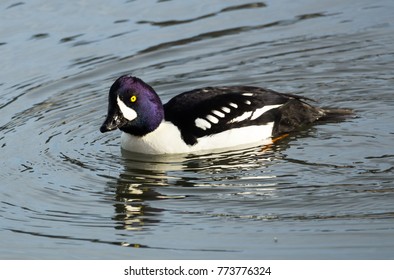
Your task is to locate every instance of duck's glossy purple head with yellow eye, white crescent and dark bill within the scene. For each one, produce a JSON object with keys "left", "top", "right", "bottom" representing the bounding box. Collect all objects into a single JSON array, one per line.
[{"left": 100, "top": 76, "right": 164, "bottom": 136}]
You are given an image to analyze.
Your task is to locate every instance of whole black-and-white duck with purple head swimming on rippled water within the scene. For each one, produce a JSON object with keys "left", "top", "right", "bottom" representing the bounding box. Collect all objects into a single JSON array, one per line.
[{"left": 100, "top": 75, "right": 351, "bottom": 155}]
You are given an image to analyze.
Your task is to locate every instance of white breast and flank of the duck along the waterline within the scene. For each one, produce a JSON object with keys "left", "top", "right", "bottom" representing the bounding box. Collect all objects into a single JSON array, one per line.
[{"left": 121, "top": 122, "right": 274, "bottom": 154}]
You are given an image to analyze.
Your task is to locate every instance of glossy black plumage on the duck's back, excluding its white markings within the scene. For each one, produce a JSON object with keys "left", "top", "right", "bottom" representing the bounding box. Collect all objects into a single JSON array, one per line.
[{"left": 164, "top": 86, "right": 307, "bottom": 145}]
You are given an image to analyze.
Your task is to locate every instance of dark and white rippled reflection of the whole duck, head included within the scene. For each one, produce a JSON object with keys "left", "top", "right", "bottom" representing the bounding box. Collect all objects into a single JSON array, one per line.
[{"left": 109, "top": 142, "right": 288, "bottom": 231}]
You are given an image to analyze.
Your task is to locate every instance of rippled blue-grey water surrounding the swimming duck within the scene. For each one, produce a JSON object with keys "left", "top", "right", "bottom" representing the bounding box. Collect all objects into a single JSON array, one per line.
[{"left": 0, "top": 0, "right": 394, "bottom": 259}]
